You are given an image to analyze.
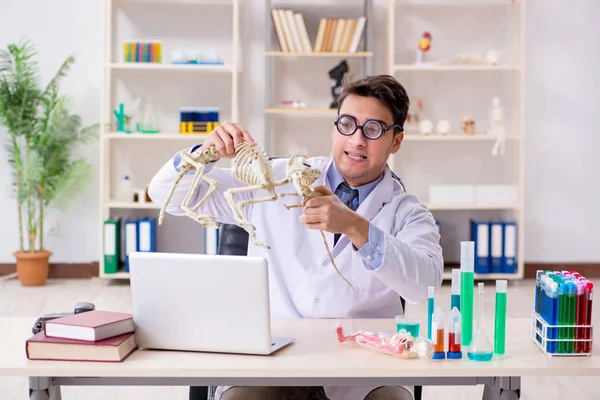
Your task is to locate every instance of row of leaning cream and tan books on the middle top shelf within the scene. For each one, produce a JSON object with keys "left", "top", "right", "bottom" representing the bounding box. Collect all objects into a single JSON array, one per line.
[{"left": 271, "top": 9, "right": 366, "bottom": 53}]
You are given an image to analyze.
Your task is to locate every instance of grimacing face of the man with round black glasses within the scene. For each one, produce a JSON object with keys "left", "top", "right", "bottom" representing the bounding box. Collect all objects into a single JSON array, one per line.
[{"left": 331, "top": 95, "right": 404, "bottom": 189}]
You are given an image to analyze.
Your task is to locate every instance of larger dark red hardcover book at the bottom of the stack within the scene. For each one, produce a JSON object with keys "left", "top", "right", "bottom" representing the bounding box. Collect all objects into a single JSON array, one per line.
[{"left": 25, "top": 332, "right": 137, "bottom": 362}]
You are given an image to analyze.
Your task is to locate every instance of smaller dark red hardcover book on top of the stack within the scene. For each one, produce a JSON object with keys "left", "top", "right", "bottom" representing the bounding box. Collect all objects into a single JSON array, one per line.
[{"left": 44, "top": 310, "right": 134, "bottom": 342}]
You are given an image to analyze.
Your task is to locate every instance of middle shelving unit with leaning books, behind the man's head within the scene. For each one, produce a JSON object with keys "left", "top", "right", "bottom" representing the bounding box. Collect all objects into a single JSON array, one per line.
[{"left": 263, "top": 0, "right": 375, "bottom": 156}]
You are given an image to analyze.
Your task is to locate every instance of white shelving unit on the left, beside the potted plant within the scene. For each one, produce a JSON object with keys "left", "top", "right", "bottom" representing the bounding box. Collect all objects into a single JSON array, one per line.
[{"left": 99, "top": 0, "right": 241, "bottom": 279}]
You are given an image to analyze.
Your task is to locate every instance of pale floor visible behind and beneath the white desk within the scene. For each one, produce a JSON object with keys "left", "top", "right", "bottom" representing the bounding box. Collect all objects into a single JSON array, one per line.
[{"left": 0, "top": 279, "right": 600, "bottom": 400}]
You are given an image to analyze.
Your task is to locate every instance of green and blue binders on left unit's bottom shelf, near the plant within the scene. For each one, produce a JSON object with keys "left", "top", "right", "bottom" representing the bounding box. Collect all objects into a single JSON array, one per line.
[{"left": 104, "top": 218, "right": 157, "bottom": 274}]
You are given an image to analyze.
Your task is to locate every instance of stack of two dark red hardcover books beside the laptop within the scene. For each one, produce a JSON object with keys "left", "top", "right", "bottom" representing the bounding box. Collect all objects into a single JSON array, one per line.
[{"left": 25, "top": 310, "right": 137, "bottom": 362}]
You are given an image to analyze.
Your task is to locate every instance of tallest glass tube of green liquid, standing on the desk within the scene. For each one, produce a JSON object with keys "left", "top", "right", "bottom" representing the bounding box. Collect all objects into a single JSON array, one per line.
[{"left": 460, "top": 241, "right": 475, "bottom": 346}]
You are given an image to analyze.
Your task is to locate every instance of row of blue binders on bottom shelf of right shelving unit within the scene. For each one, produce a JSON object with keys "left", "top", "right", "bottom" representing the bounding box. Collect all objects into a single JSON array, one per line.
[{"left": 470, "top": 220, "right": 517, "bottom": 274}]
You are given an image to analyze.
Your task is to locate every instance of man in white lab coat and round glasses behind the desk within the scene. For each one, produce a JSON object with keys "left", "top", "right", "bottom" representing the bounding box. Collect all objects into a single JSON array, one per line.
[{"left": 149, "top": 75, "right": 443, "bottom": 400}]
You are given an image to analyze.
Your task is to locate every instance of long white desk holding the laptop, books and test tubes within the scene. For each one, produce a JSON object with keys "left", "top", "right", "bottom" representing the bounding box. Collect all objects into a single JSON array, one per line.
[{"left": 0, "top": 318, "right": 600, "bottom": 400}]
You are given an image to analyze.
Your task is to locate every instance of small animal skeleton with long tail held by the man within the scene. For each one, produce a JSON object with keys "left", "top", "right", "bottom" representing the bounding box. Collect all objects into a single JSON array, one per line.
[{"left": 158, "top": 141, "right": 356, "bottom": 293}]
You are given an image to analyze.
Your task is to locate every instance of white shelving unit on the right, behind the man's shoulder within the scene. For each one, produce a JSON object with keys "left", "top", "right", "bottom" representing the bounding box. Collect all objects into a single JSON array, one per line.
[{"left": 386, "top": 0, "right": 526, "bottom": 280}]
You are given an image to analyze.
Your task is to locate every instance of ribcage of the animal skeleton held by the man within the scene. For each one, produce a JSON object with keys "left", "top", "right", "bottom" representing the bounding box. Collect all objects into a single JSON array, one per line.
[{"left": 234, "top": 142, "right": 273, "bottom": 185}]
